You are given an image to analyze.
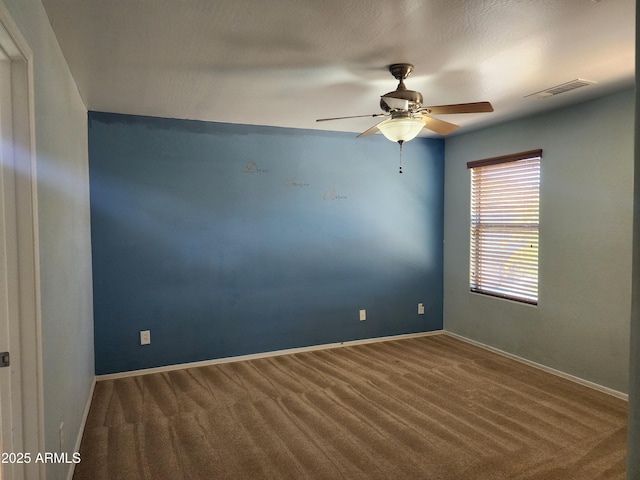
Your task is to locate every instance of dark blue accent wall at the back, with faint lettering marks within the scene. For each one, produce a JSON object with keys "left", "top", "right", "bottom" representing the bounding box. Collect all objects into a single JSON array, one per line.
[{"left": 89, "top": 112, "right": 444, "bottom": 374}]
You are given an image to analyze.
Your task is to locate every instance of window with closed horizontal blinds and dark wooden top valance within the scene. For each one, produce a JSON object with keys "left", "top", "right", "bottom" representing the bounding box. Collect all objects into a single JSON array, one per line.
[{"left": 467, "top": 150, "right": 542, "bottom": 305}]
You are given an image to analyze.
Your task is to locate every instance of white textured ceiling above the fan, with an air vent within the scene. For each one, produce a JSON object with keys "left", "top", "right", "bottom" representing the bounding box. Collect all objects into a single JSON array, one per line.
[{"left": 42, "top": 0, "right": 635, "bottom": 136}]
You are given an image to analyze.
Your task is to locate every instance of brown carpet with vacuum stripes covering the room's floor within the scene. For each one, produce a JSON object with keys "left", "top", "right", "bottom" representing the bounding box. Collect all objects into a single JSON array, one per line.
[{"left": 73, "top": 335, "right": 627, "bottom": 480}]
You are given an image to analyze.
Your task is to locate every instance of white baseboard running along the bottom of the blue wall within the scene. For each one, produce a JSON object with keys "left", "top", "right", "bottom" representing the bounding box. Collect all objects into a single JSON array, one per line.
[{"left": 96, "top": 330, "right": 444, "bottom": 382}]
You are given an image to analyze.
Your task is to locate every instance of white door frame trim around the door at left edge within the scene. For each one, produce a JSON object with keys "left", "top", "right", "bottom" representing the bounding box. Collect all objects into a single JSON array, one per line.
[{"left": 0, "top": 4, "right": 45, "bottom": 480}]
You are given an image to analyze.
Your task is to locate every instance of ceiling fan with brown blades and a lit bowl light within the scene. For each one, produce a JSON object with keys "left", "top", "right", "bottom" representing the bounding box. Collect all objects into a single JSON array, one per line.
[{"left": 316, "top": 63, "right": 493, "bottom": 173}]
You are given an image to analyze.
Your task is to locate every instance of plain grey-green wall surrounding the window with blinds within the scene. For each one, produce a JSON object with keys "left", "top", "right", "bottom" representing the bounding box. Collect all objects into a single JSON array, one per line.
[{"left": 444, "top": 91, "right": 634, "bottom": 392}]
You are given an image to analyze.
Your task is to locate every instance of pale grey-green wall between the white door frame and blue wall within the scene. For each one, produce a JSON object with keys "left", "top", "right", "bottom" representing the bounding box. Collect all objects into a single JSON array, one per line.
[{"left": 3, "top": 0, "right": 94, "bottom": 480}]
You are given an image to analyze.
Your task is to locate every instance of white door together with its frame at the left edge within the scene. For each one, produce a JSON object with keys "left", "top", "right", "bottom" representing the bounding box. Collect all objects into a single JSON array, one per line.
[{"left": 0, "top": 0, "right": 45, "bottom": 480}]
